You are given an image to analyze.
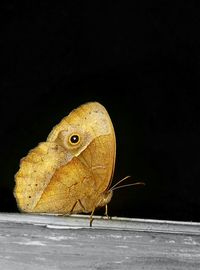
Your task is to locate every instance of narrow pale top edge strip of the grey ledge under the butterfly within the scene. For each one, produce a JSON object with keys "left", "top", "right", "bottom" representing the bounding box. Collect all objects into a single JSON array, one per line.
[{"left": 0, "top": 213, "right": 200, "bottom": 234}]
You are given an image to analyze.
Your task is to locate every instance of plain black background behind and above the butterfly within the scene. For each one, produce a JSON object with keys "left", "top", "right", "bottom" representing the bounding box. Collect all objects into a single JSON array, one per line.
[{"left": 0, "top": 1, "right": 200, "bottom": 221}]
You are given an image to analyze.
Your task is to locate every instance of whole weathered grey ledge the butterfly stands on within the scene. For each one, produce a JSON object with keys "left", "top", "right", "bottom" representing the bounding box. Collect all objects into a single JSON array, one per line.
[{"left": 0, "top": 214, "right": 200, "bottom": 270}]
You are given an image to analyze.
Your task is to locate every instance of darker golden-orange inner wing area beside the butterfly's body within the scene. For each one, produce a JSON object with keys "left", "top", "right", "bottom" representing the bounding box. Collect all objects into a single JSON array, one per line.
[{"left": 34, "top": 136, "right": 115, "bottom": 213}]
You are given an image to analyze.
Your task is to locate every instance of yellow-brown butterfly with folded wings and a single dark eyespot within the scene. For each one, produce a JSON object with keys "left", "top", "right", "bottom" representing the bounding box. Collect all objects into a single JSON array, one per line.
[{"left": 14, "top": 102, "right": 116, "bottom": 214}]
